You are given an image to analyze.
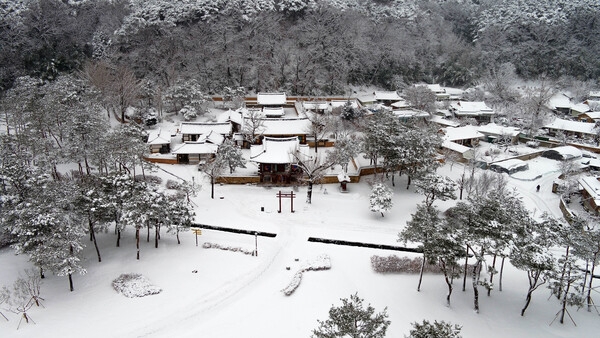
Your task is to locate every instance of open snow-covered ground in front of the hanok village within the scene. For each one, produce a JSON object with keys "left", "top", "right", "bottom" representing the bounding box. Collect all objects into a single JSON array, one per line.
[{"left": 0, "top": 158, "right": 600, "bottom": 338}]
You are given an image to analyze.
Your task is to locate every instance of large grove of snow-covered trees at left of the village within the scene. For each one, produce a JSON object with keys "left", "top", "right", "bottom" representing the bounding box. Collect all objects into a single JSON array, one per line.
[{"left": 0, "top": 75, "right": 193, "bottom": 290}]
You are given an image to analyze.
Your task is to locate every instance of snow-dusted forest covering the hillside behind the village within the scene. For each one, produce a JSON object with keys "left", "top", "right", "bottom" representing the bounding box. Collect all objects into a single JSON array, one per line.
[{"left": 0, "top": 0, "right": 600, "bottom": 95}]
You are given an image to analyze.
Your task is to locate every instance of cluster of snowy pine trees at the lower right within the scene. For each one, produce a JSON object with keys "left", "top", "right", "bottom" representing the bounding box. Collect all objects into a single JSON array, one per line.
[{"left": 399, "top": 179, "right": 600, "bottom": 323}]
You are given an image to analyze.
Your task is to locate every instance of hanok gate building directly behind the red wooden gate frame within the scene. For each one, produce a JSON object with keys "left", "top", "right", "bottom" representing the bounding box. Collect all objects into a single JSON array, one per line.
[{"left": 250, "top": 137, "right": 309, "bottom": 184}]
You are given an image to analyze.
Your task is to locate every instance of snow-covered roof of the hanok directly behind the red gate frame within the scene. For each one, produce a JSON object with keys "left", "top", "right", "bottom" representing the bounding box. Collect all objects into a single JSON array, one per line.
[{"left": 250, "top": 137, "right": 309, "bottom": 164}]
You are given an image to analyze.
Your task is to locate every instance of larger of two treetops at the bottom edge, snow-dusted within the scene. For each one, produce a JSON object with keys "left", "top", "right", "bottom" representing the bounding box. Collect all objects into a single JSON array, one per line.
[{"left": 312, "top": 294, "right": 390, "bottom": 338}]
